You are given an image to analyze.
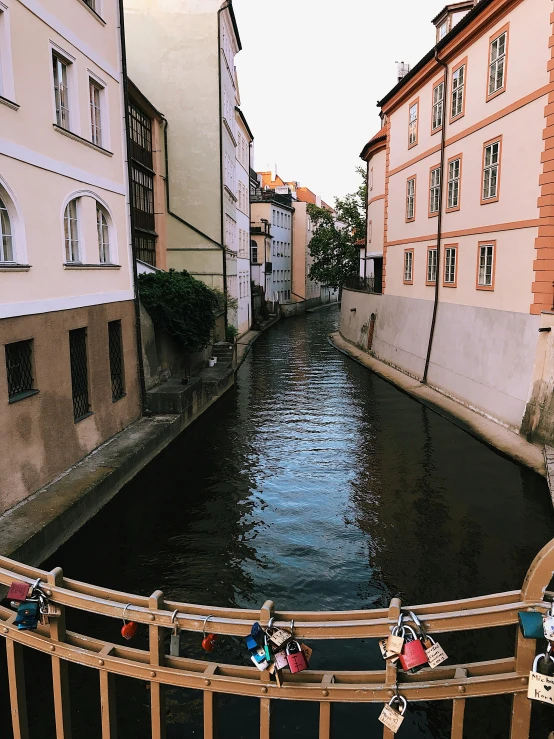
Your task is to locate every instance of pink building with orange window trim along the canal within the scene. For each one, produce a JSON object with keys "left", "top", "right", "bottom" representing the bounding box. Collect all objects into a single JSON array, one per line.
[{"left": 341, "top": 0, "right": 554, "bottom": 438}]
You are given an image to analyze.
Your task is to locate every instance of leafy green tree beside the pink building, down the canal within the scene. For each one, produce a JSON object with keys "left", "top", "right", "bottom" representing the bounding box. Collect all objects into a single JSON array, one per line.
[{"left": 307, "top": 167, "right": 367, "bottom": 289}]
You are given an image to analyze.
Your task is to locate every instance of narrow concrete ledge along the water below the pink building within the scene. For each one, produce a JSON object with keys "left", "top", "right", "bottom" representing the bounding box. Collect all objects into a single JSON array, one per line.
[{"left": 329, "top": 331, "right": 546, "bottom": 476}]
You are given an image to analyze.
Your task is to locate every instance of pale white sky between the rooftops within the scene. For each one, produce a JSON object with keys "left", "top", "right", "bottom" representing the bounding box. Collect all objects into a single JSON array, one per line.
[{"left": 233, "top": 0, "right": 446, "bottom": 204}]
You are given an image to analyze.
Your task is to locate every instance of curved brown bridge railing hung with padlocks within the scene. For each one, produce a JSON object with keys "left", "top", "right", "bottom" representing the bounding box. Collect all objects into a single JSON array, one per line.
[{"left": 0, "top": 540, "right": 554, "bottom": 739}]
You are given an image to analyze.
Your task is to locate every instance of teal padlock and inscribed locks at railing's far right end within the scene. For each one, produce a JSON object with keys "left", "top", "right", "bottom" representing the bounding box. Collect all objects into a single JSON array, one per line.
[{"left": 517, "top": 601, "right": 554, "bottom": 706}]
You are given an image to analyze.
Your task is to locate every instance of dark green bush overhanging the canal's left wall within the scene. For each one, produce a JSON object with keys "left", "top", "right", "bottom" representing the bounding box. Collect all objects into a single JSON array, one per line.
[{"left": 139, "top": 269, "right": 224, "bottom": 353}]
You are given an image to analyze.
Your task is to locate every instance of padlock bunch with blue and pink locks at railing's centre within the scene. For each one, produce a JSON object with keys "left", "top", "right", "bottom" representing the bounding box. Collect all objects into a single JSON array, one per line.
[{"left": 245, "top": 618, "right": 312, "bottom": 687}]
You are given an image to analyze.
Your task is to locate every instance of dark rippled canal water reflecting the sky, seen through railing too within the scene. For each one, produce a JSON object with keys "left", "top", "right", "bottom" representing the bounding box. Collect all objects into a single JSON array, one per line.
[{"left": 10, "top": 309, "right": 554, "bottom": 739}]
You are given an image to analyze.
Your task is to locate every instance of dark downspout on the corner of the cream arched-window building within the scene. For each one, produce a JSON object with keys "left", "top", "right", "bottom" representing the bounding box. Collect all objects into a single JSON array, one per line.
[{"left": 119, "top": 0, "right": 147, "bottom": 415}]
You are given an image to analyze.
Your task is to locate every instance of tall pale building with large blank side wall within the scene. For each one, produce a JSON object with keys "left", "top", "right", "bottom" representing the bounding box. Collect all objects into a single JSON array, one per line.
[{"left": 124, "top": 0, "right": 241, "bottom": 306}]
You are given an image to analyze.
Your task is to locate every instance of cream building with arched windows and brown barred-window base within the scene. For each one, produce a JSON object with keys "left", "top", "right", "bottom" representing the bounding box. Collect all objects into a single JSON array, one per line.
[{"left": 0, "top": 0, "right": 141, "bottom": 513}]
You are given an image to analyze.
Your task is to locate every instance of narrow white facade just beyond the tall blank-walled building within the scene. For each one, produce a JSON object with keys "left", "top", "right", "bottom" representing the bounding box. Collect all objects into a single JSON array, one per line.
[{"left": 229, "top": 106, "right": 254, "bottom": 336}]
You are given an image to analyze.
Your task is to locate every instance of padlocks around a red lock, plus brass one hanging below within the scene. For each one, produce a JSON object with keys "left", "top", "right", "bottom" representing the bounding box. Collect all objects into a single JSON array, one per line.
[{"left": 379, "top": 611, "right": 448, "bottom": 734}]
